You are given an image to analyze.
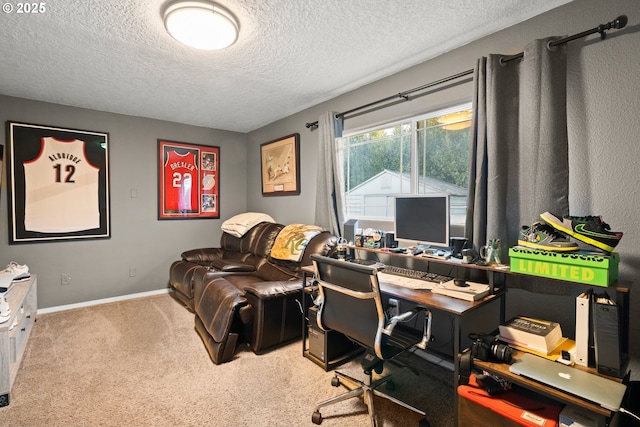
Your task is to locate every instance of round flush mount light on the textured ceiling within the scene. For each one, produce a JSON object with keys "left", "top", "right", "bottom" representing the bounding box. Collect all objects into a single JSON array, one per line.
[{"left": 164, "top": 1, "right": 240, "bottom": 50}]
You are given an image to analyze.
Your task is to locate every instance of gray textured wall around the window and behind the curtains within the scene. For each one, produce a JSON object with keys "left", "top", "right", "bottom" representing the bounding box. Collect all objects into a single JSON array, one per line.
[{"left": 247, "top": 0, "right": 640, "bottom": 378}]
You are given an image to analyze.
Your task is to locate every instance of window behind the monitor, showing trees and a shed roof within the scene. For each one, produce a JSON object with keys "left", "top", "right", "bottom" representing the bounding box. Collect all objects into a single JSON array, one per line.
[{"left": 339, "top": 104, "right": 471, "bottom": 235}]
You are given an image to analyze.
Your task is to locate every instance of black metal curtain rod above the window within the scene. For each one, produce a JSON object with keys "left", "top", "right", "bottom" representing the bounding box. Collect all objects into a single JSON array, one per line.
[{"left": 306, "top": 15, "right": 628, "bottom": 131}]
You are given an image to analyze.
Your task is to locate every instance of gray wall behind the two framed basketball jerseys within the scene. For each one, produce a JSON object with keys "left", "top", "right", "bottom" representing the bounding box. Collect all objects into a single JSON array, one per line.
[{"left": 0, "top": 96, "right": 247, "bottom": 308}]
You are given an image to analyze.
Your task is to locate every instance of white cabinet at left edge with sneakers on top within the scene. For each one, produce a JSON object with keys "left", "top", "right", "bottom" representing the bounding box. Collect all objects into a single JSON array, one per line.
[{"left": 0, "top": 274, "right": 38, "bottom": 407}]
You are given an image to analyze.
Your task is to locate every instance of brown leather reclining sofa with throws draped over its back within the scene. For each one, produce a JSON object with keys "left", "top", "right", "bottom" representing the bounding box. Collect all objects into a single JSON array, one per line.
[{"left": 169, "top": 222, "right": 337, "bottom": 364}]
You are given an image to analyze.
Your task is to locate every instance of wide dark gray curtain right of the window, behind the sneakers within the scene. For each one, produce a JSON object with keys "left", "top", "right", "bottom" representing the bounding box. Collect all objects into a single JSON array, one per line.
[{"left": 465, "top": 38, "right": 569, "bottom": 254}]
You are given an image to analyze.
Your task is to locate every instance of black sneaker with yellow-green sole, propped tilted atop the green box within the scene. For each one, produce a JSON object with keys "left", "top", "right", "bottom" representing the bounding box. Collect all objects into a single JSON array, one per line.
[{"left": 540, "top": 212, "right": 622, "bottom": 252}]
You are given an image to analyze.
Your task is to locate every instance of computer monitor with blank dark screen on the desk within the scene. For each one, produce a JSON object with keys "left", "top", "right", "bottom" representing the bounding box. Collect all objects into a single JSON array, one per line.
[{"left": 395, "top": 194, "right": 449, "bottom": 248}]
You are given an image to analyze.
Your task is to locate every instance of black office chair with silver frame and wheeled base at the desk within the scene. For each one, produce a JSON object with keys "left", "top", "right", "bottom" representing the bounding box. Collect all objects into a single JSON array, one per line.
[{"left": 311, "top": 255, "right": 431, "bottom": 427}]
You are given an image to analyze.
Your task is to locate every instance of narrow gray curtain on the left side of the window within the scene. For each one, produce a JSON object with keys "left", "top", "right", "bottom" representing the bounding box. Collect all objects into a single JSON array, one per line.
[{"left": 315, "top": 111, "right": 344, "bottom": 236}]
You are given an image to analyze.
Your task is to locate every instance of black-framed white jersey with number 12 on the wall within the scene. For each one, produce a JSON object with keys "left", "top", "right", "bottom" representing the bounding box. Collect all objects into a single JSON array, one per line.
[{"left": 7, "top": 122, "right": 111, "bottom": 244}]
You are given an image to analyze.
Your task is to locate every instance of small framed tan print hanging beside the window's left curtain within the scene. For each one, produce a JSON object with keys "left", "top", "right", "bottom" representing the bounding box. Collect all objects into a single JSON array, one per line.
[{"left": 260, "top": 133, "right": 300, "bottom": 196}]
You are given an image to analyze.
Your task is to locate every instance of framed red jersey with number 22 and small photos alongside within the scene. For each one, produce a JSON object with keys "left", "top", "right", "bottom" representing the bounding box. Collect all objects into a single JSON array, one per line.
[{"left": 158, "top": 139, "right": 220, "bottom": 219}]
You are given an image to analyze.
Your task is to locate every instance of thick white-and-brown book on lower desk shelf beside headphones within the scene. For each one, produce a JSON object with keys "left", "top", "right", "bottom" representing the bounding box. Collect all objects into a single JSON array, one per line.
[{"left": 498, "top": 316, "right": 565, "bottom": 354}]
